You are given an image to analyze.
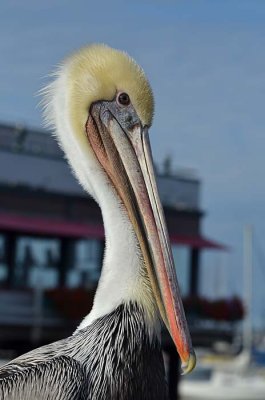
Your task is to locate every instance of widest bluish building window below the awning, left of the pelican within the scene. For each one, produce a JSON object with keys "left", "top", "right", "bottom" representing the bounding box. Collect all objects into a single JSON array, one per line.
[{"left": 13, "top": 236, "right": 60, "bottom": 289}]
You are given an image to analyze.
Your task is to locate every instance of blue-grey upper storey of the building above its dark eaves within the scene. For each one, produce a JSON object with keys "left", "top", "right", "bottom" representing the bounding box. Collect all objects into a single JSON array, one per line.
[{"left": 0, "top": 124, "right": 200, "bottom": 211}]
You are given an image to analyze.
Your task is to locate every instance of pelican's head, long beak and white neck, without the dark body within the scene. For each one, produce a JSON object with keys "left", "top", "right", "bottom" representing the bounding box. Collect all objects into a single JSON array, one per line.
[{"left": 45, "top": 45, "right": 195, "bottom": 373}]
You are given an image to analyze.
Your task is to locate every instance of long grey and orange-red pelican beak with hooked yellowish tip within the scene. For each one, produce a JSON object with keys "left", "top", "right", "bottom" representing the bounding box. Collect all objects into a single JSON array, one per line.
[{"left": 86, "top": 104, "right": 196, "bottom": 374}]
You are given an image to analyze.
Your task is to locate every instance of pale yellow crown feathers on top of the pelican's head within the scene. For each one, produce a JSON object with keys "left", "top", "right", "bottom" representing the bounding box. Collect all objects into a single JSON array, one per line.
[{"left": 66, "top": 44, "right": 154, "bottom": 134}]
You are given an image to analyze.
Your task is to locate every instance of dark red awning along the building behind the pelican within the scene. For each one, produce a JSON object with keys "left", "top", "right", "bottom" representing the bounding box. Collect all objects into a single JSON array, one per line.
[{"left": 0, "top": 213, "right": 226, "bottom": 250}]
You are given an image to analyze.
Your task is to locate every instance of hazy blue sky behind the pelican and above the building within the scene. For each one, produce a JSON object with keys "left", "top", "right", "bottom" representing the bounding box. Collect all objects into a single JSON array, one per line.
[{"left": 0, "top": 0, "right": 265, "bottom": 324}]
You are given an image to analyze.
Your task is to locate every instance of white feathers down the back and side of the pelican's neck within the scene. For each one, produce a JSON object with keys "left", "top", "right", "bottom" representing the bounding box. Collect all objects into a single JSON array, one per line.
[{"left": 43, "top": 70, "right": 157, "bottom": 330}]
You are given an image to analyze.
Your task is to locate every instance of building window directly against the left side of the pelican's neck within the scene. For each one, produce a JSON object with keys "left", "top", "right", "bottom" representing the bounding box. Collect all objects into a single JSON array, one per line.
[{"left": 66, "top": 239, "right": 101, "bottom": 288}]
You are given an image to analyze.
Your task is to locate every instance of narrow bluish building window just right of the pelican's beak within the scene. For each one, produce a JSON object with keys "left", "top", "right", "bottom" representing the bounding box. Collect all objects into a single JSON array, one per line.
[{"left": 172, "top": 245, "right": 190, "bottom": 297}]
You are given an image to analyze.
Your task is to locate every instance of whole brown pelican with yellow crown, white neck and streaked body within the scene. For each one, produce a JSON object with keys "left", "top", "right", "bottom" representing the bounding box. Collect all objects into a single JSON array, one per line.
[{"left": 0, "top": 45, "right": 195, "bottom": 400}]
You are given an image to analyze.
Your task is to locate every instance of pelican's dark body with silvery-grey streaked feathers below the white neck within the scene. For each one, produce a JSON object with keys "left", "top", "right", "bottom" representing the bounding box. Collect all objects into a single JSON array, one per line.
[{"left": 0, "top": 304, "right": 167, "bottom": 400}]
